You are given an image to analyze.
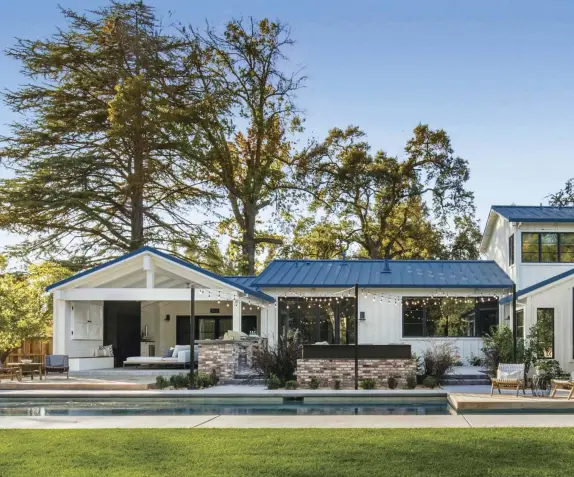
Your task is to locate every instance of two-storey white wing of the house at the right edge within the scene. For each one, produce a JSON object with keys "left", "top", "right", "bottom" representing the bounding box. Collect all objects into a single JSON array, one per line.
[{"left": 481, "top": 206, "right": 574, "bottom": 371}]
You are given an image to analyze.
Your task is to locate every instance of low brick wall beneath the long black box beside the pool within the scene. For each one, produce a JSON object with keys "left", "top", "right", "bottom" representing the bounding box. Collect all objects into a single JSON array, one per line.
[{"left": 297, "top": 359, "right": 417, "bottom": 389}]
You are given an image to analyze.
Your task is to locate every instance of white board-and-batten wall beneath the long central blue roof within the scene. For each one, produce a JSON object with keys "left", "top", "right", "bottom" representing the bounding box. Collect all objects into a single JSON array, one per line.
[{"left": 262, "top": 288, "right": 488, "bottom": 358}]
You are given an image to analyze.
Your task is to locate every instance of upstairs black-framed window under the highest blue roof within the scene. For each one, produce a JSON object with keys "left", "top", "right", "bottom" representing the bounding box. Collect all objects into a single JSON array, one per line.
[{"left": 522, "top": 232, "right": 574, "bottom": 263}]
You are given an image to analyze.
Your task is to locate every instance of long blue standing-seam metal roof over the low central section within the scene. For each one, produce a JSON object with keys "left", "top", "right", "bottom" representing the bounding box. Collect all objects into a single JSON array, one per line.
[{"left": 252, "top": 260, "right": 513, "bottom": 288}]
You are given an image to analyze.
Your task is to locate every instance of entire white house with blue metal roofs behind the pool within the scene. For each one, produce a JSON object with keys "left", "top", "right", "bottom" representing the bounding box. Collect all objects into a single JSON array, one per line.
[{"left": 49, "top": 206, "right": 574, "bottom": 370}]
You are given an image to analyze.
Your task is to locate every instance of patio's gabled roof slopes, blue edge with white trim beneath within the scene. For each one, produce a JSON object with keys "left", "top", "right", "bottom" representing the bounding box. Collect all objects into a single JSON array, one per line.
[{"left": 46, "top": 247, "right": 275, "bottom": 303}]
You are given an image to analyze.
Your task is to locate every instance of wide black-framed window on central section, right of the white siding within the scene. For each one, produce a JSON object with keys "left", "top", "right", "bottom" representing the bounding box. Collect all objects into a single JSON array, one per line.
[{"left": 403, "top": 297, "right": 498, "bottom": 338}]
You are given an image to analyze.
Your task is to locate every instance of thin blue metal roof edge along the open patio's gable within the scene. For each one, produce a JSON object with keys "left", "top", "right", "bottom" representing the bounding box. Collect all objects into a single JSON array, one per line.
[{"left": 46, "top": 247, "right": 275, "bottom": 303}]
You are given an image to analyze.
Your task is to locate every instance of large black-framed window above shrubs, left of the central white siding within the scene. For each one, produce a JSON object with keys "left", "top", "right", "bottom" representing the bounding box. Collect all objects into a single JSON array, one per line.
[{"left": 278, "top": 297, "right": 355, "bottom": 344}]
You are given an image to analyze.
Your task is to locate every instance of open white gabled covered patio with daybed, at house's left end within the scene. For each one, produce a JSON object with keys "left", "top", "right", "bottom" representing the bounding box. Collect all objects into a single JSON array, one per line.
[{"left": 48, "top": 247, "right": 274, "bottom": 371}]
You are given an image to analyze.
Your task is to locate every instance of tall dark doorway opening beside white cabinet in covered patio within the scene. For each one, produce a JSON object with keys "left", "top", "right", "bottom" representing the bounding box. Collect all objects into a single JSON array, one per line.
[{"left": 104, "top": 301, "right": 141, "bottom": 368}]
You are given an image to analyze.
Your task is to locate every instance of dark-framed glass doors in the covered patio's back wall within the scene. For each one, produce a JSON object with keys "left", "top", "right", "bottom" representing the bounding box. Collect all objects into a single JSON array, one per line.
[{"left": 175, "top": 315, "right": 257, "bottom": 345}]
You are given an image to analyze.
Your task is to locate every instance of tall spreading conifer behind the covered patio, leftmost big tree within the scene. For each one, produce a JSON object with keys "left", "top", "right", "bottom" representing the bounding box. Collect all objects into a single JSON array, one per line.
[{"left": 0, "top": 2, "right": 214, "bottom": 264}]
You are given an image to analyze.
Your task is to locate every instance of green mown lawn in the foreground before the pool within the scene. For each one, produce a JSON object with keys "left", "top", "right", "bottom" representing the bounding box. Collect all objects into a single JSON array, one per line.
[{"left": 0, "top": 428, "right": 574, "bottom": 477}]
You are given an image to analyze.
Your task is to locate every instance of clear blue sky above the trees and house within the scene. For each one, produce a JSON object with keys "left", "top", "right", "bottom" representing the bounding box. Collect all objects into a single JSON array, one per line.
[{"left": 0, "top": 0, "right": 574, "bottom": 249}]
